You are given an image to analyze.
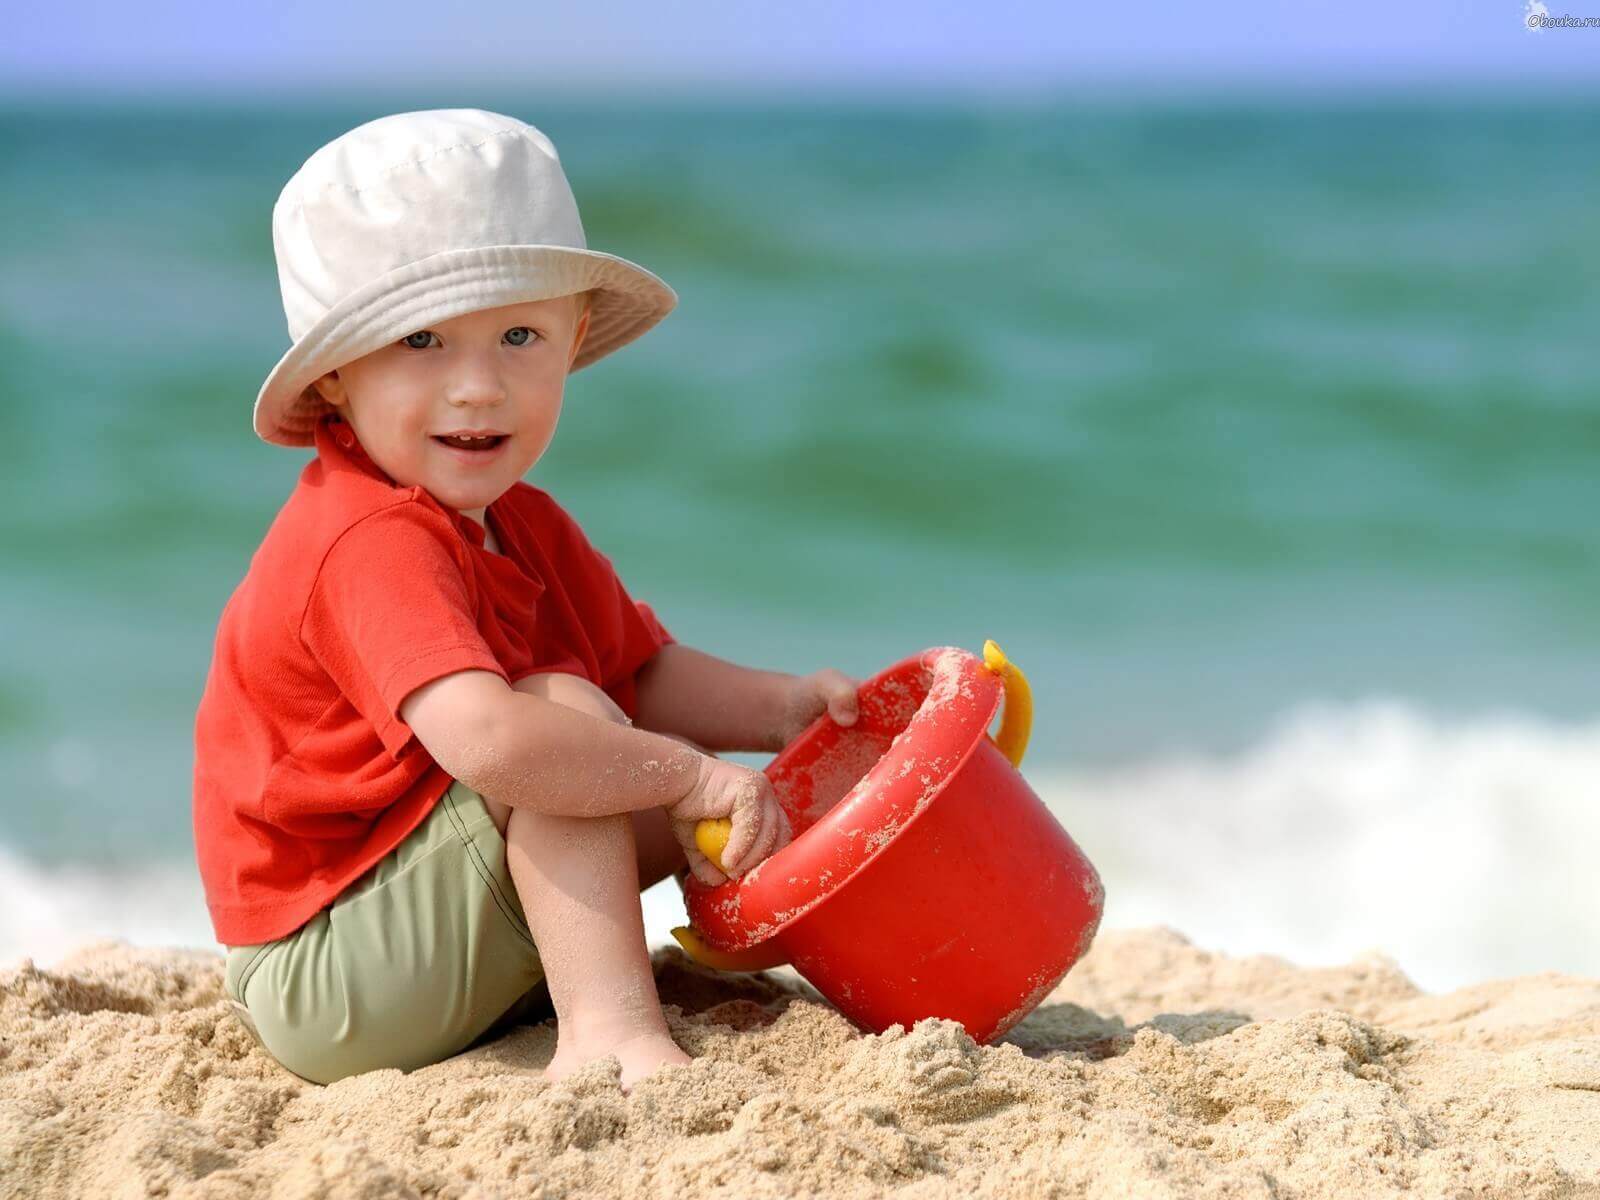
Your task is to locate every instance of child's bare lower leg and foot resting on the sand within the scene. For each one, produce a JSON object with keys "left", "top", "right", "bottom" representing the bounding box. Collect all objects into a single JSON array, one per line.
[{"left": 506, "top": 808, "right": 690, "bottom": 1088}]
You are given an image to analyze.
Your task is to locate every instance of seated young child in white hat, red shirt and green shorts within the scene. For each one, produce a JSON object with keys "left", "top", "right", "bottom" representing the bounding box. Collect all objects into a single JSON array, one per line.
[{"left": 194, "top": 109, "right": 858, "bottom": 1088}]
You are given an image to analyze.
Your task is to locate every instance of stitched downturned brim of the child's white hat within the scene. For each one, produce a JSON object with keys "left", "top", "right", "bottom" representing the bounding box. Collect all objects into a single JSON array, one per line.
[{"left": 254, "top": 245, "right": 678, "bottom": 446}]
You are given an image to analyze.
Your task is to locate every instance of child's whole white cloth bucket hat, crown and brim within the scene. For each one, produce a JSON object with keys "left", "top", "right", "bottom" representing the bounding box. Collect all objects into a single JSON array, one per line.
[{"left": 254, "top": 109, "right": 678, "bottom": 446}]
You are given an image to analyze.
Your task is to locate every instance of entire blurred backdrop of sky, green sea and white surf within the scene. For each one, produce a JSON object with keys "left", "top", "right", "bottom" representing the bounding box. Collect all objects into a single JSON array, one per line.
[{"left": 0, "top": 0, "right": 1600, "bottom": 990}]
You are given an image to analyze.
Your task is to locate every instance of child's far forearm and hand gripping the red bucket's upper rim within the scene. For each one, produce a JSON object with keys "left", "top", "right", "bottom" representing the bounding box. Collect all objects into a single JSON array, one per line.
[{"left": 635, "top": 642, "right": 856, "bottom": 754}]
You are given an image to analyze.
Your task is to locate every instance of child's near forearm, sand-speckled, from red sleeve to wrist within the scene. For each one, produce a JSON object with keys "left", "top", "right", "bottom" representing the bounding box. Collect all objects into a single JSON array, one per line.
[{"left": 400, "top": 670, "right": 706, "bottom": 816}]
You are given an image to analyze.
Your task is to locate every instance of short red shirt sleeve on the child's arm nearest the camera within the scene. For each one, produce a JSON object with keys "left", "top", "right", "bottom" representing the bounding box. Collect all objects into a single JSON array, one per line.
[{"left": 301, "top": 502, "right": 509, "bottom": 760}]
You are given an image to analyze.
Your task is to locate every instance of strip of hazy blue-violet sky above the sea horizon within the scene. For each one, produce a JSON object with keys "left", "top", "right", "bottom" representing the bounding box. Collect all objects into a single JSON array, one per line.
[{"left": 0, "top": 0, "right": 1600, "bottom": 98}]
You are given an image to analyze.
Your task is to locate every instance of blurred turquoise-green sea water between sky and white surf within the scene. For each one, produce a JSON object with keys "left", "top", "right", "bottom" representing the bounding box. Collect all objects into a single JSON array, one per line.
[{"left": 0, "top": 98, "right": 1600, "bottom": 889}]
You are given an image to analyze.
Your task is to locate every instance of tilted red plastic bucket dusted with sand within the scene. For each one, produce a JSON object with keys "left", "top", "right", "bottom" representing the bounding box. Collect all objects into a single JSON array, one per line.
[{"left": 685, "top": 646, "right": 1104, "bottom": 1042}]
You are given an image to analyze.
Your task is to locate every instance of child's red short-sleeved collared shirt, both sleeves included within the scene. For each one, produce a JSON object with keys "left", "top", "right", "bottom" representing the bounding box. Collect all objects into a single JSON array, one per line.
[{"left": 194, "top": 413, "right": 675, "bottom": 946}]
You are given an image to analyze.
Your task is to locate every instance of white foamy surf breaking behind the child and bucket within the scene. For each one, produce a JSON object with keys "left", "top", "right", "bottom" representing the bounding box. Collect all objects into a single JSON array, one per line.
[{"left": 0, "top": 701, "right": 1600, "bottom": 990}]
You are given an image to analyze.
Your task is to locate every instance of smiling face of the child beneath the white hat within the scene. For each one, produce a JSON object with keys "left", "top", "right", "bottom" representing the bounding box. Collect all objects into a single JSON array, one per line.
[{"left": 315, "top": 296, "right": 589, "bottom": 522}]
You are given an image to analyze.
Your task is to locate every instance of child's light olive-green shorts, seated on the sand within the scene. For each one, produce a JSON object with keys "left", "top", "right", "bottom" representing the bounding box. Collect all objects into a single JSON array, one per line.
[{"left": 224, "top": 779, "right": 554, "bottom": 1083}]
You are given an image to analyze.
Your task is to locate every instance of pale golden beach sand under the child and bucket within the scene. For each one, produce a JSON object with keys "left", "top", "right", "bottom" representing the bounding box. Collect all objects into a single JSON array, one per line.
[{"left": 0, "top": 928, "right": 1600, "bottom": 1200}]
